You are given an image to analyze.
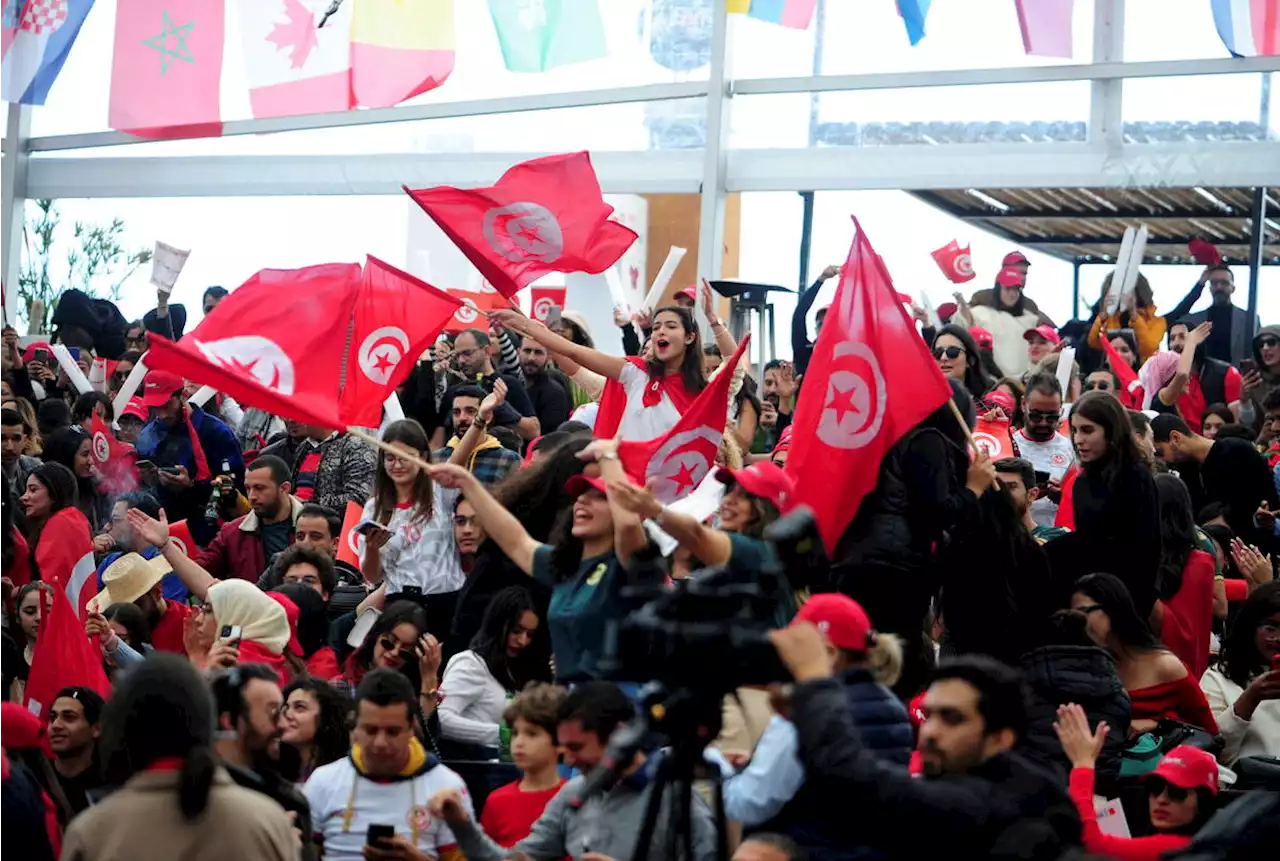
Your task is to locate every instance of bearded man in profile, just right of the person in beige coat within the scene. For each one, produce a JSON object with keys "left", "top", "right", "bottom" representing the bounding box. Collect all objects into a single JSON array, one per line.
[{"left": 211, "top": 664, "right": 317, "bottom": 860}]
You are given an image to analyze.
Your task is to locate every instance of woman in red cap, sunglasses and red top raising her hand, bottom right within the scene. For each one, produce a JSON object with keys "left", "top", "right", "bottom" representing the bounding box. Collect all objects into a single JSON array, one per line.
[{"left": 1053, "top": 704, "right": 1217, "bottom": 861}]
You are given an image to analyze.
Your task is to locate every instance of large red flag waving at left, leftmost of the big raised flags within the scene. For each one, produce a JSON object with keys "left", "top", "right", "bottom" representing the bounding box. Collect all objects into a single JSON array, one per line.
[{"left": 147, "top": 264, "right": 361, "bottom": 429}]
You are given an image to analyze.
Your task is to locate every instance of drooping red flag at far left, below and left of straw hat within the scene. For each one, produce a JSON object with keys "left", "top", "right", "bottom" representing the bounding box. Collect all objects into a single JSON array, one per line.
[{"left": 26, "top": 580, "right": 111, "bottom": 720}]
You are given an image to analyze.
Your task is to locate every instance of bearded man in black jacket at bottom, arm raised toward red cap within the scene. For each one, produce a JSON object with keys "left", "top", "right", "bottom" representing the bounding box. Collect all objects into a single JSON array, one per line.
[{"left": 772, "top": 623, "right": 1080, "bottom": 858}]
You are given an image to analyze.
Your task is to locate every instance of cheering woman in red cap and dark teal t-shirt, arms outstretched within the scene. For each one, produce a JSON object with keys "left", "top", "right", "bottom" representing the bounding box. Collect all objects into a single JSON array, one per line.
[{"left": 430, "top": 440, "right": 664, "bottom": 682}]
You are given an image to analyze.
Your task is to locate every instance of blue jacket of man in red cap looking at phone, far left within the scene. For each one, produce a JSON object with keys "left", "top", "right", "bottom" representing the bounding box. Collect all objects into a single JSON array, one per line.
[{"left": 136, "top": 409, "right": 244, "bottom": 545}]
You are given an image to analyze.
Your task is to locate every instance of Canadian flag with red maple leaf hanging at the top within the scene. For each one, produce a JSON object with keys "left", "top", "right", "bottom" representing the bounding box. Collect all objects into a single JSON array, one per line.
[{"left": 239, "top": 0, "right": 351, "bottom": 116}]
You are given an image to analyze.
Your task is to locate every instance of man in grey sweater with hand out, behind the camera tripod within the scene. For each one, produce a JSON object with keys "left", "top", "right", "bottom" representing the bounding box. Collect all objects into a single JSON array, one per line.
[{"left": 430, "top": 682, "right": 717, "bottom": 861}]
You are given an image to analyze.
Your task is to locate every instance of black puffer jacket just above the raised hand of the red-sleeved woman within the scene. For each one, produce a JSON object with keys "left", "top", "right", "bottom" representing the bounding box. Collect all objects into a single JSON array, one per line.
[{"left": 1019, "top": 646, "right": 1130, "bottom": 797}]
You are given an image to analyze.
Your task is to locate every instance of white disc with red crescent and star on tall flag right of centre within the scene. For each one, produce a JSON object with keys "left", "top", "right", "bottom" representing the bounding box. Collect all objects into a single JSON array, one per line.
[{"left": 818, "top": 340, "right": 888, "bottom": 449}]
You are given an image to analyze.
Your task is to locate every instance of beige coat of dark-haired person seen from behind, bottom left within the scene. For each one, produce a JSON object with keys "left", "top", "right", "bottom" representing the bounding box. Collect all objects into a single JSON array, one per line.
[{"left": 61, "top": 769, "right": 300, "bottom": 861}]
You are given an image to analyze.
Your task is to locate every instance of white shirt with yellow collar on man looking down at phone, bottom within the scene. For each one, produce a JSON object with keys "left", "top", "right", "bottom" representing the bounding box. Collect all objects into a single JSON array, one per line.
[{"left": 302, "top": 757, "right": 475, "bottom": 861}]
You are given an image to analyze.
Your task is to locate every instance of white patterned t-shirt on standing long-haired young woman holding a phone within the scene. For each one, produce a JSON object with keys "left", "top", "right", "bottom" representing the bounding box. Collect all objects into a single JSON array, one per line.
[{"left": 360, "top": 485, "right": 466, "bottom": 595}]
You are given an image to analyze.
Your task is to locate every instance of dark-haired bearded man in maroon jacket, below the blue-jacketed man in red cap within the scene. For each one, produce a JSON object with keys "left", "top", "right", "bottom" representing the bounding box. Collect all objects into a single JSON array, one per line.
[{"left": 196, "top": 455, "right": 302, "bottom": 583}]
